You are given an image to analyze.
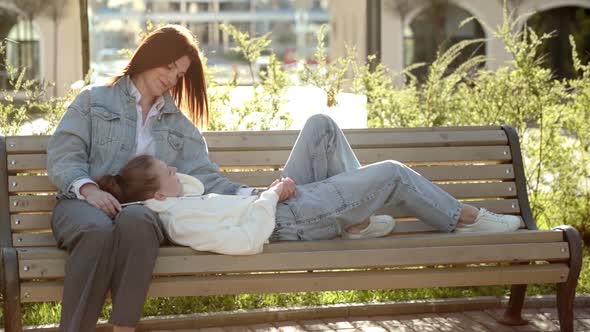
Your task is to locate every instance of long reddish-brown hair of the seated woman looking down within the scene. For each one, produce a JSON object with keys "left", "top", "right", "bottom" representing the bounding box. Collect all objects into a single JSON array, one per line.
[{"left": 110, "top": 24, "right": 209, "bottom": 127}]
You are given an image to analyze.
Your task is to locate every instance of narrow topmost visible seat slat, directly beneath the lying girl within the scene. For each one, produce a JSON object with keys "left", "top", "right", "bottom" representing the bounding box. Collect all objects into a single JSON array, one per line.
[{"left": 17, "top": 230, "right": 565, "bottom": 260}]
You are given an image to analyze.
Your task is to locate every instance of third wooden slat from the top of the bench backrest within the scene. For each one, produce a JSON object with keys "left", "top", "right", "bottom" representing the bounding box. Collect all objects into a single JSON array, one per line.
[{"left": 8, "top": 165, "right": 514, "bottom": 193}]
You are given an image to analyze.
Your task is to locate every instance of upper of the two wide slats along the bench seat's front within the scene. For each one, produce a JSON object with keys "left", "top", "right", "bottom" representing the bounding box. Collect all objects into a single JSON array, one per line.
[{"left": 19, "top": 242, "right": 569, "bottom": 279}]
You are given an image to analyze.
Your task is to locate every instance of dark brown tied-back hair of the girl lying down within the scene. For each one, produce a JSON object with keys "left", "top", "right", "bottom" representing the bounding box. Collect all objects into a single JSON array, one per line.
[{"left": 96, "top": 155, "right": 160, "bottom": 204}]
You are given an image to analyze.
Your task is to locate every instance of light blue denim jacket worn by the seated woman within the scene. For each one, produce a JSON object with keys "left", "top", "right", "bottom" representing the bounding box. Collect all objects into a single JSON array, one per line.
[{"left": 47, "top": 76, "right": 245, "bottom": 198}]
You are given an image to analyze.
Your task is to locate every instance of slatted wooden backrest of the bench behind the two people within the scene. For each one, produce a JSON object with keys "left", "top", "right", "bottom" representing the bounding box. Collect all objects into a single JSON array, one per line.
[{"left": 0, "top": 127, "right": 536, "bottom": 247}]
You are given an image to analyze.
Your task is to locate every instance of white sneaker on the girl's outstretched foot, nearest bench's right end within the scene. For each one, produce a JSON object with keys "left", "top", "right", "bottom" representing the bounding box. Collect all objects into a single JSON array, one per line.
[{"left": 455, "top": 209, "right": 520, "bottom": 233}]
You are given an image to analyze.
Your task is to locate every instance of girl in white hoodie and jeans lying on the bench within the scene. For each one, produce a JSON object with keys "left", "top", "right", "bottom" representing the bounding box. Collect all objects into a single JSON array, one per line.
[{"left": 97, "top": 115, "right": 520, "bottom": 255}]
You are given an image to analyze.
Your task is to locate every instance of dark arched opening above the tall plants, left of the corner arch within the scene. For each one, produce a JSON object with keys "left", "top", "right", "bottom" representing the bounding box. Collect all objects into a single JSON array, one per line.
[{"left": 404, "top": 0, "right": 486, "bottom": 79}]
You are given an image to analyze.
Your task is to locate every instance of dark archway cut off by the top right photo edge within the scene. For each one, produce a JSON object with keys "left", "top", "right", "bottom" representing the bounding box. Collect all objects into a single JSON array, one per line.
[{"left": 527, "top": 6, "right": 590, "bottom": 79}]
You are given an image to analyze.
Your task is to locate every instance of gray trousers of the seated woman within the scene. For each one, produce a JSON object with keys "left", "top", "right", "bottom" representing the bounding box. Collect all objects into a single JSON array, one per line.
[{"left": 52, "top": 199, "right": 165, "bottom": 332}]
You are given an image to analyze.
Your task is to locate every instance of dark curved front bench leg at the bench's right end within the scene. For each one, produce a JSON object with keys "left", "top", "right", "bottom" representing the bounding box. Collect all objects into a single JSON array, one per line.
[{"left": 554, "top": 225, "right": 582, "bottom": 332}]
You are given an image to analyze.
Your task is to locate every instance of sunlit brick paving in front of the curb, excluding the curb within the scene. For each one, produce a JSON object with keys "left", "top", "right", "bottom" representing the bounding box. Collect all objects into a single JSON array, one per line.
[{"left": 150, "top": 307, "right": 590, "bottom": 332}]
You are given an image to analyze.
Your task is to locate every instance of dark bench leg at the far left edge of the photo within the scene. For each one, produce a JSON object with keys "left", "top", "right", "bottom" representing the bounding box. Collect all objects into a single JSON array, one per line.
[{"left": 0, "top": 248, "right": 23, "bottom": 332}]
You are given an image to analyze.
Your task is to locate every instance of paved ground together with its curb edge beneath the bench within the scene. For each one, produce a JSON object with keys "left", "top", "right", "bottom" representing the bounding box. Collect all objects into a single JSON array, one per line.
[{"left": 22, "top": 295, "right": 590, "bottom": 332}]
